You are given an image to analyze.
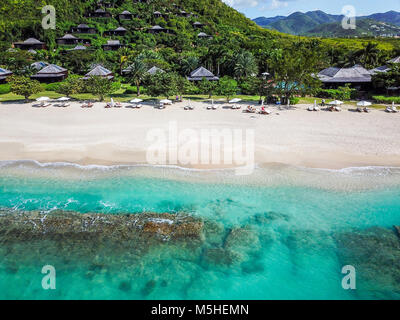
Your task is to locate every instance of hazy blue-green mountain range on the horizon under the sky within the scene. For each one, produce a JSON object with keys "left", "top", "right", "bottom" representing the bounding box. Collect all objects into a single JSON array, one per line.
[{"left": 253, "top": 10, "right": 400, "bottom": 37}]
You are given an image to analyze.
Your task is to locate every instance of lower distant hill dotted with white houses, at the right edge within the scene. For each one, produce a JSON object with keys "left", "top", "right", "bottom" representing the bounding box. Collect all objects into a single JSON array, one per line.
[{"left": 303, "top": 18, "right": 400, "bottom": 38}]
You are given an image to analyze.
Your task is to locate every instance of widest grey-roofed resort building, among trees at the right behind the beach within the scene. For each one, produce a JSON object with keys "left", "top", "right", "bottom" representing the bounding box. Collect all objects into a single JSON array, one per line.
[{"left": 318, "top": 65, "right": 371, "bottom": 89}]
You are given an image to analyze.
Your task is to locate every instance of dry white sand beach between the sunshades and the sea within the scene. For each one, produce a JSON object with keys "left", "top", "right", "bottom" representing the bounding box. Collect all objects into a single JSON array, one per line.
[{"left": 0, "top": 101, "right": 400, "bottom": 169}]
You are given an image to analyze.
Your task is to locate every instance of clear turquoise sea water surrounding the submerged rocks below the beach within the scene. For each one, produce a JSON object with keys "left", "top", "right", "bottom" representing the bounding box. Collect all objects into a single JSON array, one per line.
[{"left": 0, "top": 164, "right": 400, "bottom": 299}]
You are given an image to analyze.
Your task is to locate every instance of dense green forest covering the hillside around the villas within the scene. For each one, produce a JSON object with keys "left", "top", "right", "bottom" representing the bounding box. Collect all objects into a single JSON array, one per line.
[{"left": 0, "top": 0, "right": 400, "bottom": 100}]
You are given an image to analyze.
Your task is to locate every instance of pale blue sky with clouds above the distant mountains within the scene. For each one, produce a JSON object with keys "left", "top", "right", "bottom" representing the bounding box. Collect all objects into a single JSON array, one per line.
[{"left": 223, "top": 0, "right": 400, "bottom": 19}]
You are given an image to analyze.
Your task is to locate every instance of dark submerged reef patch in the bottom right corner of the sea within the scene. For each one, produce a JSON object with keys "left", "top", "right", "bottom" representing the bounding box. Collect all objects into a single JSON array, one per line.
[{"left": 335, "top": 227, "right": 400, "bottom": 299}]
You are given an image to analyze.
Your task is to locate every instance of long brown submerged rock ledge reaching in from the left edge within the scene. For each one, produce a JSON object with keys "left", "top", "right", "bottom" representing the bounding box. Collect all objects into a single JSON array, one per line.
[{"left": 0, "top": 210, "right": 204, "bottom": 243}]
